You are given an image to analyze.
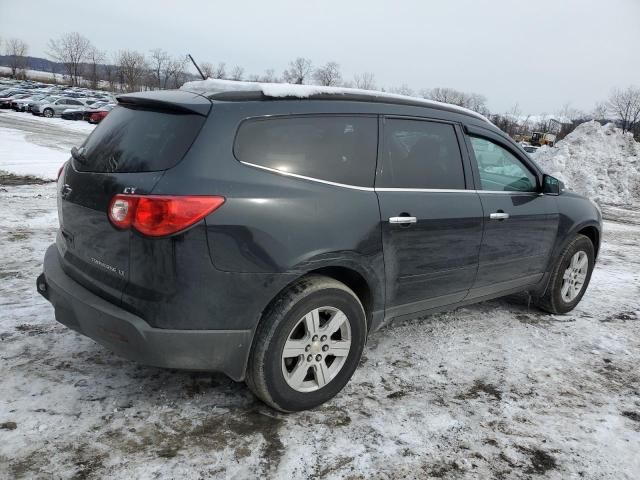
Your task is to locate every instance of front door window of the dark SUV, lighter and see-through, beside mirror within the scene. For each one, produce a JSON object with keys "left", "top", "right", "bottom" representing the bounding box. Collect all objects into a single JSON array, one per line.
[{"left": 470, "top": 137, "right": 537, "bottom": 192}]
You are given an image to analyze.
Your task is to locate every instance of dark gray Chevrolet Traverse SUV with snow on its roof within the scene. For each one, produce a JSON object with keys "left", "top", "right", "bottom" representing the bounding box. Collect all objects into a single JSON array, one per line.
[{"left": 37, "top": 82, "right": 602, "bottom": 411}]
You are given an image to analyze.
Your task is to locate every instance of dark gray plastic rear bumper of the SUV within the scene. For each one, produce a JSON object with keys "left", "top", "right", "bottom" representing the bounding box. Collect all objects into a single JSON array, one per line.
[{"left": 37, "top": 245, "right": 252, "bottom": 381}]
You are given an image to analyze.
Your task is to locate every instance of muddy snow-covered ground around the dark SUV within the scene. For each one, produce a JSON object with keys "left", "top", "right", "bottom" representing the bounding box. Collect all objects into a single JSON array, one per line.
[{"left": 0, "top": 114, "right": 640, "bottom": 480}]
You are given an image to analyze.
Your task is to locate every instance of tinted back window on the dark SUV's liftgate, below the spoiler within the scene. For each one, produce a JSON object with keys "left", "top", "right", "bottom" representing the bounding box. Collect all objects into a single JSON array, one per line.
[{"left": 74, "top": 106, "right": 205, "bottom": 172}]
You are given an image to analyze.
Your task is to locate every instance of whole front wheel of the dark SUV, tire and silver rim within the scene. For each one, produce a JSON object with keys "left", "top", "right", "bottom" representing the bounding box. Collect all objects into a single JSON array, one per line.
[{"left": 537, "top": 234, "right": 595, "bottom": 313}]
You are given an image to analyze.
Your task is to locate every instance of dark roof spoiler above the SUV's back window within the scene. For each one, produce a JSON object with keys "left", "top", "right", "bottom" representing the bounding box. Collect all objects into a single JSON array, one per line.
[{"left": 116, "top": 90, "right": 212, "bottom": 117}]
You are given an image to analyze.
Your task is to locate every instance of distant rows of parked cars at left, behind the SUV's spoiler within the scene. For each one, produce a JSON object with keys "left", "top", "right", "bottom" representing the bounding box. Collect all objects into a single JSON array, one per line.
[{"left": 0, "top": 80, "right": 116, "bottom": 123}]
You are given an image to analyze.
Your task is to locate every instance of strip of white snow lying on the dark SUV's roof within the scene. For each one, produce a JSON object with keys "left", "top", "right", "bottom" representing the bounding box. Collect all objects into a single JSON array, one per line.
[{"left": 180, "top": 78, "right": 491, "bottom": 123}]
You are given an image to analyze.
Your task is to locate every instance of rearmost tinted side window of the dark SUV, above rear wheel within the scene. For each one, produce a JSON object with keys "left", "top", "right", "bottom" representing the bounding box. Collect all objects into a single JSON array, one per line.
[{"left": 234, "top": 115, "right": 378, "bottom": 187}]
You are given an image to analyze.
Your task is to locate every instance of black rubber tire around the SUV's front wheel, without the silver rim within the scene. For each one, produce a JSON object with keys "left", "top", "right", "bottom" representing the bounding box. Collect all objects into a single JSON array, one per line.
[{"left": 536, "top": 234, "right": 595, "bottom": 313}]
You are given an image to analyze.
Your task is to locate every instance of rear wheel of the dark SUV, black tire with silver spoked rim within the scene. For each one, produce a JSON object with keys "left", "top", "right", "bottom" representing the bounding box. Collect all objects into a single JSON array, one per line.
[{"left": 246, "top": 275, "right": 367, "bottom": 412}]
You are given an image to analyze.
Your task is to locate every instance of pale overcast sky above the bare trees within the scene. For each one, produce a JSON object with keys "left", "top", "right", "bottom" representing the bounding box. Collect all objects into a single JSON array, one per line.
[{"left": 0, "top": 0, "right": 640, "bottom": 114}]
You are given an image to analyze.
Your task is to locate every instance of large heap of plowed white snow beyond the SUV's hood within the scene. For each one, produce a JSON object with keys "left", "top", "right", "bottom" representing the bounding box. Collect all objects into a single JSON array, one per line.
[{"left": 533, "top": 121, "right": 640, "bottom": 204}]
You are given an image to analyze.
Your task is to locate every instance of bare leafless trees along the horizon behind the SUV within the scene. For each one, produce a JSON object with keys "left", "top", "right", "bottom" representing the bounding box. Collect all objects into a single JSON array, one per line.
[{"left": 0, "top": 32, "right": 640, "bottom": 139}]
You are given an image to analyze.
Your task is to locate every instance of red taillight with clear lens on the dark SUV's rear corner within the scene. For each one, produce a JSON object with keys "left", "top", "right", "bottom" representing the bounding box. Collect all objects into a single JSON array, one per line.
[{"left": 108, "top": 194, "right": 224, "bottom": 237}]
